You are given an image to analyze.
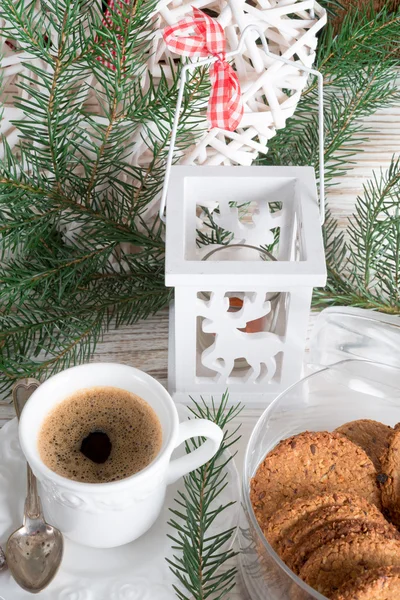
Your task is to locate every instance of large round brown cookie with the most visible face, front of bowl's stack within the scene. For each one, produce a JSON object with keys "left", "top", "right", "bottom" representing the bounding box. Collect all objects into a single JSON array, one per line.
[{"left": 250, "top": 431, "right": 380, "bottom": 523}]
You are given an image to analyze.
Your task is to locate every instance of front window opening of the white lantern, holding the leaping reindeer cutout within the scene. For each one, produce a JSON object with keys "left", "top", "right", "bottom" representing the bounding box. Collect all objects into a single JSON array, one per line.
[{"left": 196, "top": 290, "right": 290, "bottom": 385}]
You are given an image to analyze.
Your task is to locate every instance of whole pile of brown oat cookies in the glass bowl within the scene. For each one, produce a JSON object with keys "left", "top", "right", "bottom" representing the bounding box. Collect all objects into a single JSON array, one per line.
[{"left": 250, "top": 420, "right": 400, "bottom": 600}]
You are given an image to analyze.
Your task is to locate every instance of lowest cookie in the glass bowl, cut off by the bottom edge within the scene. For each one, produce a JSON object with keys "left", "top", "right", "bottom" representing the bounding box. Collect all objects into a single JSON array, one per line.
[{"left": 331, "top": 567, "right": 400, "bottom": 600}]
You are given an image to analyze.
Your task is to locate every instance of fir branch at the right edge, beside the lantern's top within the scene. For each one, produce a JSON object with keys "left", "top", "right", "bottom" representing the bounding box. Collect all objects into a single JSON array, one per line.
[{"left": 314, "top": 158, "right": 400, "bottom": 315}]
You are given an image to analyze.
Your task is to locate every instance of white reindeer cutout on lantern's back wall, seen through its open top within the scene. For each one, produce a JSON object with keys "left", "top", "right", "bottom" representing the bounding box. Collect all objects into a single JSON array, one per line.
[{"left": 213, "top": 201, "right": 282, "bottom": 246}]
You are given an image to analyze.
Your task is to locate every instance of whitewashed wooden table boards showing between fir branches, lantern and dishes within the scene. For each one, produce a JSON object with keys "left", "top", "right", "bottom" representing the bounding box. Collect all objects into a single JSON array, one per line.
[{"left": 0, "top": 101, "right": 400, "bottom": 600}]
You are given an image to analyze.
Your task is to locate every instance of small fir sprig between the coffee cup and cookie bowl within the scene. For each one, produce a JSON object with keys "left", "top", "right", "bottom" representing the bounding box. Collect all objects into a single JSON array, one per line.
[{"left": 167, "top": 392, "right": 241, "bottom": 600}]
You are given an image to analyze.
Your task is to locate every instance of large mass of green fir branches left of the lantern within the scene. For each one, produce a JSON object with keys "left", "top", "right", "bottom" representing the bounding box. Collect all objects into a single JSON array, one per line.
[{"left": 0, "top": 0, "right": 209, "bottom": 393}]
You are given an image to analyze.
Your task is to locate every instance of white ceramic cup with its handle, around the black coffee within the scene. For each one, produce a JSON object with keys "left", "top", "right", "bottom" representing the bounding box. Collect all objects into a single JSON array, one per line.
[{"left": 19, "top": 363, "right": 222, "bottom": 548}]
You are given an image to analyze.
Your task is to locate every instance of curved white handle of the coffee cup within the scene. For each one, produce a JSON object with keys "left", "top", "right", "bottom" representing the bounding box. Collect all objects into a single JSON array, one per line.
[{"left": 167, "top": 419, "right": 224, "bottom": 485}]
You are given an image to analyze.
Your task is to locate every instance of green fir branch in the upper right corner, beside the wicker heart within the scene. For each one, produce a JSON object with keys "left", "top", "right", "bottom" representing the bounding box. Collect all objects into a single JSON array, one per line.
[{"left": 259, "top": 7, "right": 400, "bottom": 183}]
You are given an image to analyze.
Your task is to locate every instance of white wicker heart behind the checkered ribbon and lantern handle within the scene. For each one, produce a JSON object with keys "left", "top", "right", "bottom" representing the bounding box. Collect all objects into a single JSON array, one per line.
[{"left": 0, "top": 0, "right": 326, "bottom": 166}]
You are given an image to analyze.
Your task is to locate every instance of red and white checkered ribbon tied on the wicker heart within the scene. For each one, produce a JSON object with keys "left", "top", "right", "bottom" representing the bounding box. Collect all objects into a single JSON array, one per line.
[{"left": 163, "top": 7, "right": 243, "bottom": 131}]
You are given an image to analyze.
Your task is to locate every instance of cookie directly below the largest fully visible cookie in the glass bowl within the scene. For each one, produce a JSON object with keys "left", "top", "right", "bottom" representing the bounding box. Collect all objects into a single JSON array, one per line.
[{"left": 260, "top": 492, "right": 374, "bottom": 550}]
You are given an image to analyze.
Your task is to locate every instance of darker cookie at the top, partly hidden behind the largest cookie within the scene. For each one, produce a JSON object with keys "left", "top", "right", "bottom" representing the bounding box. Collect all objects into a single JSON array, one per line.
[{"left": 335, "top": 419, "right": 393, "bottom": 472}]
